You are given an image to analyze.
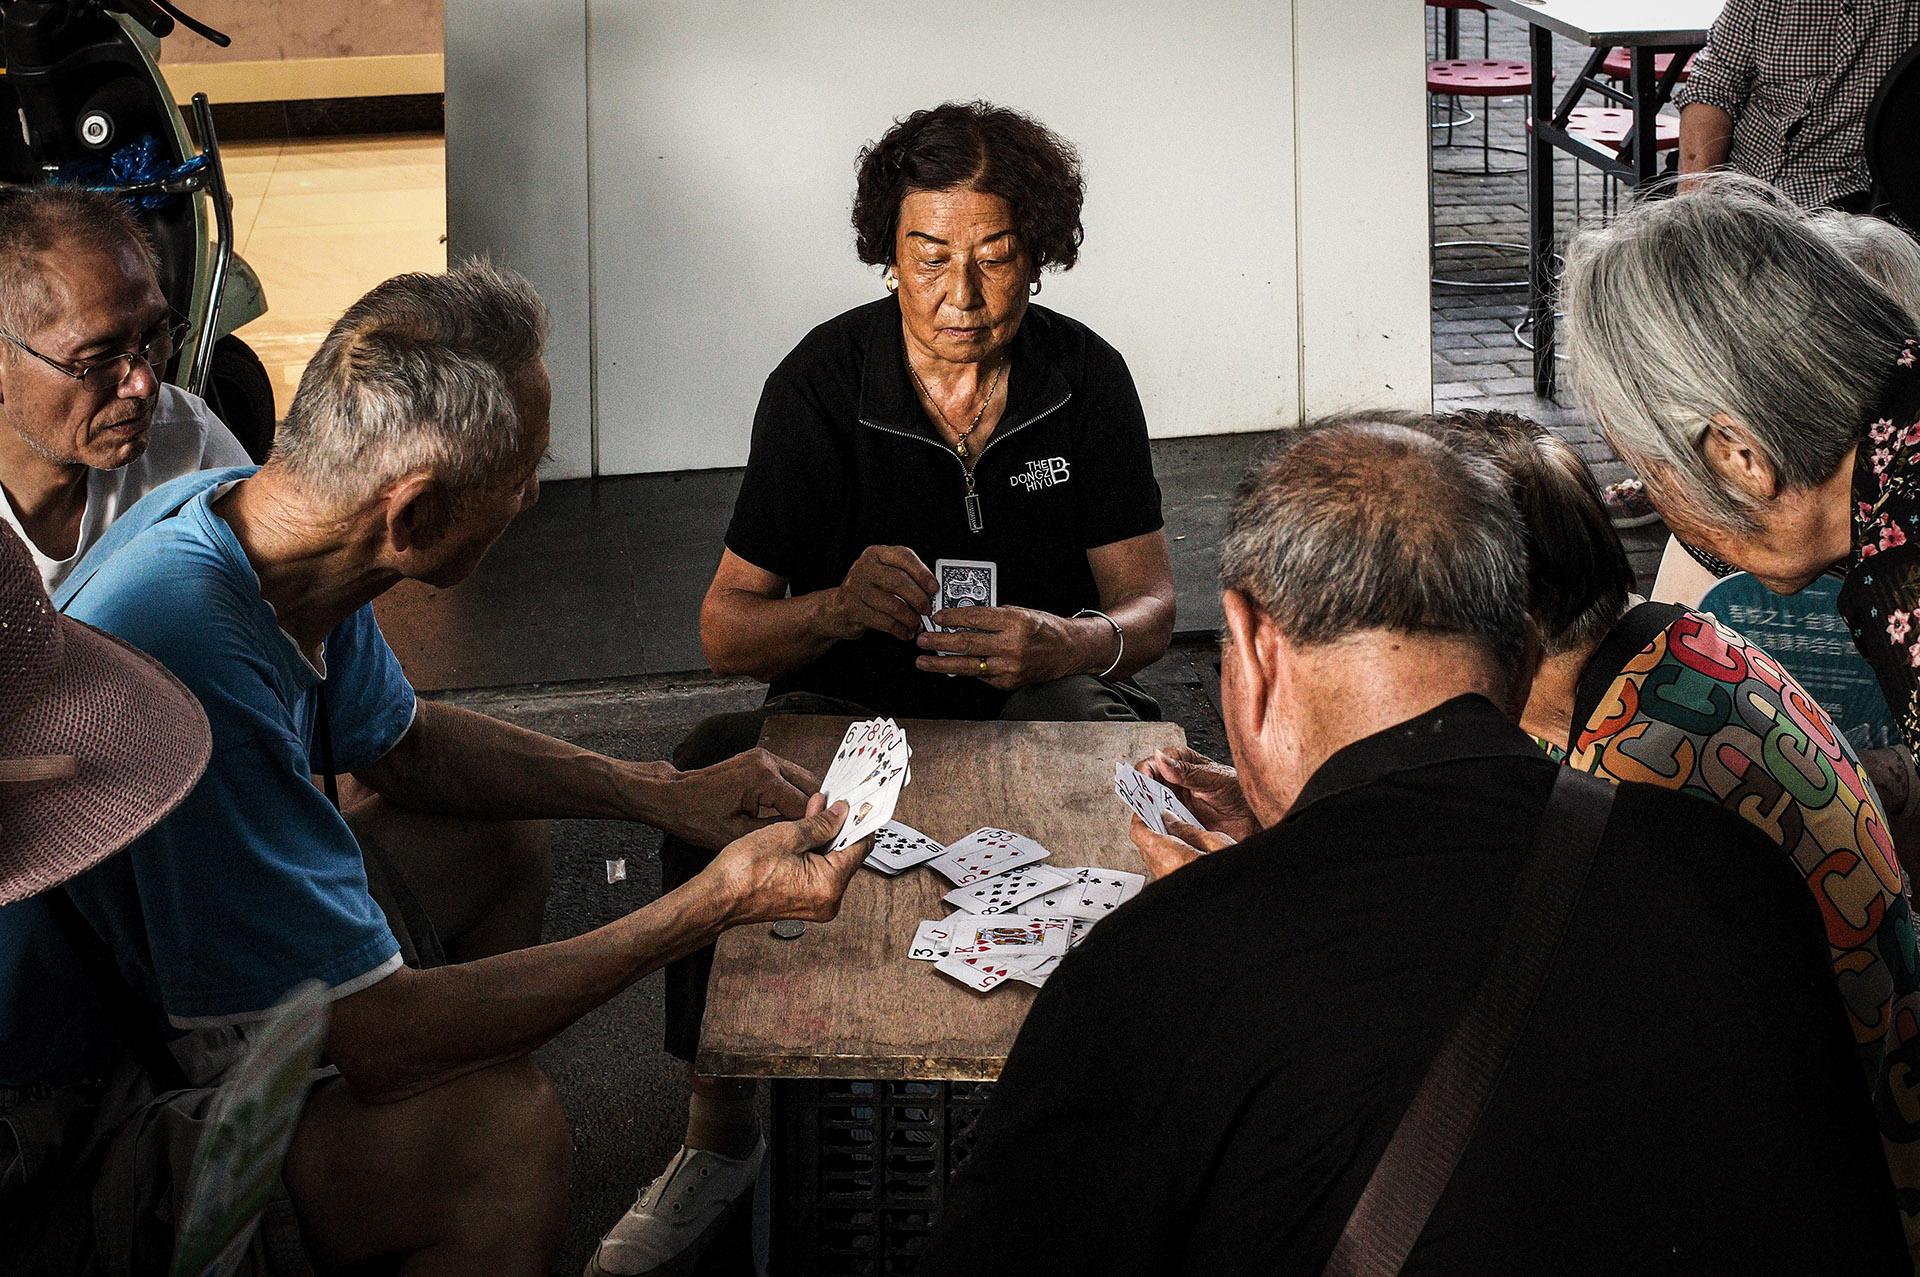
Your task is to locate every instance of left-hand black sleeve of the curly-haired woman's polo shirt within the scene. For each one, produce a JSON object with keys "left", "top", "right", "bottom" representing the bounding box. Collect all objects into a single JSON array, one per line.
[{"left": 726, "top": 371, "right": 851, "bottom": 582}]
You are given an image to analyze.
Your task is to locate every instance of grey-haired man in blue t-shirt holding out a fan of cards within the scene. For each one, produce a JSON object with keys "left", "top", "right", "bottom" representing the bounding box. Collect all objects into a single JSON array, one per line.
[{"left": 0, "top": 265, "right": 866, "bottom": 1273}]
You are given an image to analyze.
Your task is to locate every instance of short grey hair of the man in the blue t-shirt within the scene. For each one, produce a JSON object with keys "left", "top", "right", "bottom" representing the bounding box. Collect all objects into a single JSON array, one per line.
[{"left": 271, "top": 261, "right": 547, "bottom": 507}]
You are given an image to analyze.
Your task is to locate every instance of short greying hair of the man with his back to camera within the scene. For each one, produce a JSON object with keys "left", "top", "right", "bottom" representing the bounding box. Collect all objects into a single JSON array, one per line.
[{"left": 1219, "top": 413, "right": 1528, "bottom": 680}]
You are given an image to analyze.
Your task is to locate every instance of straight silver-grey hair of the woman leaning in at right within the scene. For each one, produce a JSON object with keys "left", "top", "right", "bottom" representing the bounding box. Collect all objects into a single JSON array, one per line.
[{"left": 1561, "top": 179, "right": 1914, "bottom": 532}]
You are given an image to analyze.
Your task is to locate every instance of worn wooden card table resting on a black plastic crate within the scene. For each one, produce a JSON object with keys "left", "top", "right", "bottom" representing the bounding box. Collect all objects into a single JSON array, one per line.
[{"left": 697, "top": 716, "right": 1187, "bottom": 1277}]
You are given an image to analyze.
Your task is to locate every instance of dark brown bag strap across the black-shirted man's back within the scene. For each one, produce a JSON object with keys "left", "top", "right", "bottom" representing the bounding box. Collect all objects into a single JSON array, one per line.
[{"left": 1327, "top": 766, "right": 1615, "bottom": 1277}]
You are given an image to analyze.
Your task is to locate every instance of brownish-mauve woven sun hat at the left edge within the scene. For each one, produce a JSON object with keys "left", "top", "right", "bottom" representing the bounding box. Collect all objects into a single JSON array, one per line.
[{"left": 0, "top": 616, "right": 211, "bottom": 904}]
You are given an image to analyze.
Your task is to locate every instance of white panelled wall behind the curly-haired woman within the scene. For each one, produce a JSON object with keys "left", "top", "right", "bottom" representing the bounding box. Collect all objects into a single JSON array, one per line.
[{"left": 447, "top": 0, "right": 1428, "bottom": 474}]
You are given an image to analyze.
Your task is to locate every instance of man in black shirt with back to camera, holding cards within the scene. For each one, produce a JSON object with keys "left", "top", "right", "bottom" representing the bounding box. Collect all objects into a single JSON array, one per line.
[{"left": 920, "top": 419, "right": 1910, "bottom": 1277}]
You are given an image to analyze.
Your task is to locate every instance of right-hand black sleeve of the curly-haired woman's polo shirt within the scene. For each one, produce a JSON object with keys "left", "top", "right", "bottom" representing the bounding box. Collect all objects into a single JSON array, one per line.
[{"left": 1073, "top": 332, "right": 1162, "bottom": 549}]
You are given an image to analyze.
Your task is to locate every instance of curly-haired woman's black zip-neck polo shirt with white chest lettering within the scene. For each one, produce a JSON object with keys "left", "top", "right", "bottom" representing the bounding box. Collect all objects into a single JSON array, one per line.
[{"left": 726, "top": 296, "right": 1162, "bottom": 718}]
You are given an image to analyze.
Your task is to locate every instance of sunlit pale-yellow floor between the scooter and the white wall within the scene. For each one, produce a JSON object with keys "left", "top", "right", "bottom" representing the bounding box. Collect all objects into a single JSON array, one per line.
[{"left": 221, "top": 134, "right": 447, "bottom": 413}]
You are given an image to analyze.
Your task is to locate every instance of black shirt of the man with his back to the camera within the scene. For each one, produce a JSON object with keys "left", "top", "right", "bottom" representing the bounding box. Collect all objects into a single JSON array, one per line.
[{"left": 916, "top": 695, "right": 1912, "bottom": 1277}]
